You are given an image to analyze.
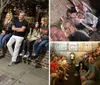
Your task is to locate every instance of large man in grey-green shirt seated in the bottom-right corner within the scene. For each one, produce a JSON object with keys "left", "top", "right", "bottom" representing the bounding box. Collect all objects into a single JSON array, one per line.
[{"left": 82, "top": 57, "right": 100, "bottom": 85}]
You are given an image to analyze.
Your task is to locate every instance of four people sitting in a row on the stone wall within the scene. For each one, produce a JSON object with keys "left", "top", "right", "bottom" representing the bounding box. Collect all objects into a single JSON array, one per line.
[{"left": 0, "top": 11, "right": 49, "bottom": 66}]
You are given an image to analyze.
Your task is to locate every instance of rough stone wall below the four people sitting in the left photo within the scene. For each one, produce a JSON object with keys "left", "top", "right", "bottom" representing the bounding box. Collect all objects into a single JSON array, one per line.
[{"left": 0, "top": 50, "right": 49, "bottom": 70}]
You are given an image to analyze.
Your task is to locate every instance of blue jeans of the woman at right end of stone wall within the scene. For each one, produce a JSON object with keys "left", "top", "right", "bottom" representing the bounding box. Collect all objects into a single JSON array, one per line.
[{"left": 33, "top": 40, "right": 48, "bottom": 56}]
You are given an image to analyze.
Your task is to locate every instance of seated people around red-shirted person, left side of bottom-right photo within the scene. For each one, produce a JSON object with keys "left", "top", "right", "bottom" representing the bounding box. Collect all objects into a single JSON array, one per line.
[{"left": 50, "top": 55, "right": 70, "bottom": 85}]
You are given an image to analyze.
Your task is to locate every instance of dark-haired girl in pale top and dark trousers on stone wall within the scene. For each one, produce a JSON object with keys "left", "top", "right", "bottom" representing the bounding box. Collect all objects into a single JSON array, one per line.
[{"left": 19, "top": 22, "right": 40, "bottom": 58}]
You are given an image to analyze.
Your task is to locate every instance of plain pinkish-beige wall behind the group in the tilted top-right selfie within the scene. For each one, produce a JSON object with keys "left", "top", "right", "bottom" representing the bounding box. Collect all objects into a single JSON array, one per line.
[{"left": 50, "top": 0, "right": 68, "bottom": 24}]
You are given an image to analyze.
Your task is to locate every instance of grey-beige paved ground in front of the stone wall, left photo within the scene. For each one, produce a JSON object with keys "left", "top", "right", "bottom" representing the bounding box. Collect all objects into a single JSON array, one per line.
[{"left": 0, "top": 57, "right": 48, "bottom": 85}]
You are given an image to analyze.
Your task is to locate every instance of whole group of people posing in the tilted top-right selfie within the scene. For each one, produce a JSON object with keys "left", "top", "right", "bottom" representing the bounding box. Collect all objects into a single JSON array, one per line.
[{"left": 50, "top": 0, "right": 100, "bottom": 41}]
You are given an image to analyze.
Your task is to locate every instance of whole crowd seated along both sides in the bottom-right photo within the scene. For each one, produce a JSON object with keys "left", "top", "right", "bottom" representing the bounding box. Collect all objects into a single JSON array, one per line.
[{"left": 50, "top": 50, "right": 100, "bottom": 85}]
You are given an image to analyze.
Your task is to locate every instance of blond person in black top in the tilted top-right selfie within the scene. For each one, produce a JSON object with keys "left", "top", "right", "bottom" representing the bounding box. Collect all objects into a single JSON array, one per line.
[{"left": 62, "top": 20, "right": 90, "bottom": 41}]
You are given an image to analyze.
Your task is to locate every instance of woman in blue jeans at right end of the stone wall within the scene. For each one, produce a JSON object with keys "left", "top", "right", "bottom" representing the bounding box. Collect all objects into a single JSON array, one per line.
[{"left": 32, "top": 17, "right": 49, "bottom": 58}]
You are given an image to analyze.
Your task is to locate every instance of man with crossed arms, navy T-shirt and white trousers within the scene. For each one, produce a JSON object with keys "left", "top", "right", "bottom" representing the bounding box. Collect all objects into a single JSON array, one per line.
[{"left": 7, "top": 12, "right": 27, "bottom": 66}]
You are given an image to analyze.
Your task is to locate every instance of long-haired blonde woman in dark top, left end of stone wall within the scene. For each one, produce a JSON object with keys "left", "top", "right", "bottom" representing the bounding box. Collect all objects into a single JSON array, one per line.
[{"left": 0, "top": 12, "right": 13, "bottom": 56}]
